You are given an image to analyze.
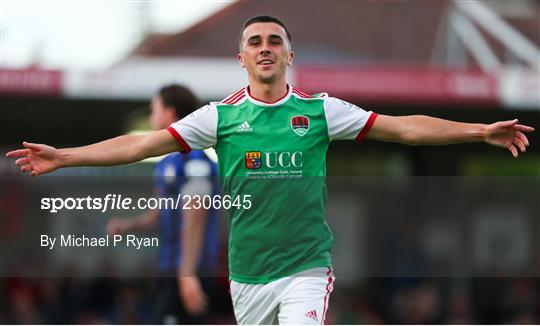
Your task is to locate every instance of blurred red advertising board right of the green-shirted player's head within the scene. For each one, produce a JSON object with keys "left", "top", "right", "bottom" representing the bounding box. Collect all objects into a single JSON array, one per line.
[{"left": 295, "top": 66, "right": 500, "bottom": 105}]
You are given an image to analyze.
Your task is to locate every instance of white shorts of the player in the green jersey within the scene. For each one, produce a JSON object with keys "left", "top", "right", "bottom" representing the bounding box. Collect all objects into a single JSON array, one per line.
[{"left": 231, "top": 267, "right": 335, "bottom": 325}]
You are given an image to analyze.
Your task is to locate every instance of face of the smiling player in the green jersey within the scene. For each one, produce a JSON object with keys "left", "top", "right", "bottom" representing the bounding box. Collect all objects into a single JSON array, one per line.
[{"left": 238, "top": 23, "right": 294, "bottom": 84}]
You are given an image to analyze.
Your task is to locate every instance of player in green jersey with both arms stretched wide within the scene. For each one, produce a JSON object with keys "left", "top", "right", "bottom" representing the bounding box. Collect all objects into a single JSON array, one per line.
[{"left": 7, "top": 16, "right": 534, "bottom": 324}]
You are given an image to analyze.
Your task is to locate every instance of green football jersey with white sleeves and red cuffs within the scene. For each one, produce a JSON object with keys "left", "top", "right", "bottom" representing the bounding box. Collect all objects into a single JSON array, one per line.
[{"left": 168, "top": 85, "right": 376, "bottom": 283}]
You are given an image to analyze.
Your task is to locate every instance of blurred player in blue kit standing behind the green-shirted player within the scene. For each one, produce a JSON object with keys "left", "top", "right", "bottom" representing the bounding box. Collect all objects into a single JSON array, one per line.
[{"left": 107, "top": 85, "right": 218, "bottom": 324}]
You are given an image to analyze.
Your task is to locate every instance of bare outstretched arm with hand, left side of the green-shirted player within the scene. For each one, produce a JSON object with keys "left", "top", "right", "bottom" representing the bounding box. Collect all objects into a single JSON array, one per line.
[{"left": 6, "top": 130, "right": 181, "bottom": 176}]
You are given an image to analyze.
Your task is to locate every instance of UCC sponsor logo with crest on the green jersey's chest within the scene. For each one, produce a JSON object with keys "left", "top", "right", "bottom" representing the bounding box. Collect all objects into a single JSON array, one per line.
[{"left": 245, "top": 151, "right": 303, "bottom": 170}]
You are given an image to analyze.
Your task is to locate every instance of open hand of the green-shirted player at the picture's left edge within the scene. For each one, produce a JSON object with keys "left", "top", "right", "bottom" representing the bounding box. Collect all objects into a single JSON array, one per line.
[{"left": 6, "top": 142, "right": 60, "bottom": 177}]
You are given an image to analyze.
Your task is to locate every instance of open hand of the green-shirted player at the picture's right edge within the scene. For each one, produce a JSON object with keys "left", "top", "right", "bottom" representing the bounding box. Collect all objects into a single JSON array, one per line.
[{"left": 484, "top": 119, "right": 534, "bottom": 157}]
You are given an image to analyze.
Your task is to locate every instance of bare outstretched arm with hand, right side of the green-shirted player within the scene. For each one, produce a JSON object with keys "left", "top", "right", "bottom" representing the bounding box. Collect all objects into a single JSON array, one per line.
[{"left": 366, "top": 115, "right": 534, "bottom": 157}]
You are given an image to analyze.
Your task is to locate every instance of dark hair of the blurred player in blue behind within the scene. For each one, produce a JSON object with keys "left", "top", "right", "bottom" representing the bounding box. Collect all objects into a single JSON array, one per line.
[{"left": 158, "top": 84, "right": 200, "bottom": 119}]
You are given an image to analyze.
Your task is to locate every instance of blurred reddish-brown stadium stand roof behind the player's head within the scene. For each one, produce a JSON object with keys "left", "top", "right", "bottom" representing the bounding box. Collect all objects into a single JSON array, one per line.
[{"left": 133, "top": 0, "right": 540, "bottom": 68}]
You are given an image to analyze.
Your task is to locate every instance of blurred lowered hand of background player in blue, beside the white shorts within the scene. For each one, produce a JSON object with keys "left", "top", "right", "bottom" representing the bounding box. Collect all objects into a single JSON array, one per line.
[{"left": 178, "top": 276, "right": 208, "bottom": 316}]
